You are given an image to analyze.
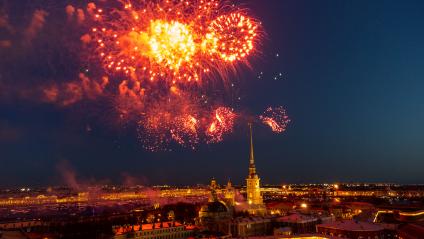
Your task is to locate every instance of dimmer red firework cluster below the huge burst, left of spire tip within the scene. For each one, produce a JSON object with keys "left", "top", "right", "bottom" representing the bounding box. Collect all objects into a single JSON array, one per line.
[{"left": 139, "top": 89, "right": 237, "bottom": 151}]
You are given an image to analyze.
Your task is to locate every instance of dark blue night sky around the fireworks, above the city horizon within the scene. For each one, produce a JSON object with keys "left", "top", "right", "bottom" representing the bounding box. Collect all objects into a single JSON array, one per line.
[{"left": 0, "top": 0, "right": 424, "bottom": 187}]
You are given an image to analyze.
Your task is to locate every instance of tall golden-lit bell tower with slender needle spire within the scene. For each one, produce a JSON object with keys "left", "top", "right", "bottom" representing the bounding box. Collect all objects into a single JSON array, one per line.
[{"left": 246, "top": 123, "right": 266, "bottom": 215}]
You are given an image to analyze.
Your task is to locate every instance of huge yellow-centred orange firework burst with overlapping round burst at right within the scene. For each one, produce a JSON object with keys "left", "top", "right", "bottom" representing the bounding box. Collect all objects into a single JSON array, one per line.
[{"left": 91, "top": 0, "right": 259, "bottom": 84}]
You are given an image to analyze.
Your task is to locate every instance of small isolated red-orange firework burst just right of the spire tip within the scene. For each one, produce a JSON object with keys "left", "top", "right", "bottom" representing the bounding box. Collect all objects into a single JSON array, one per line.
[{"left": 259, "top": 106, "right": 290, "bottom": 133}]
